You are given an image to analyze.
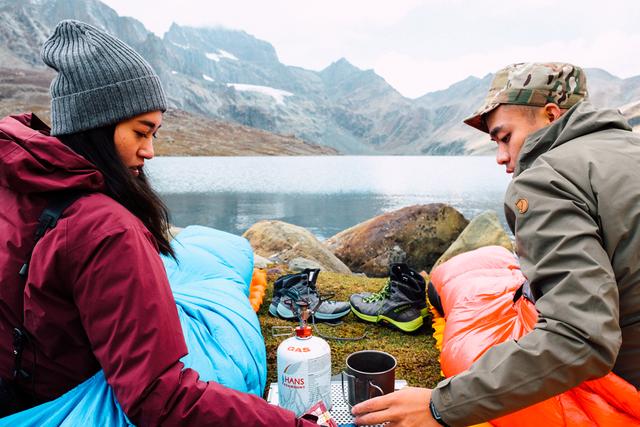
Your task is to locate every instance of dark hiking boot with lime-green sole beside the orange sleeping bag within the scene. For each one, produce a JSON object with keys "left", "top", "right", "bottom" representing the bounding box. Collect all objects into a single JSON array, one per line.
[{"left": 349, "top": 263, "right": 429, "bottom": 332}]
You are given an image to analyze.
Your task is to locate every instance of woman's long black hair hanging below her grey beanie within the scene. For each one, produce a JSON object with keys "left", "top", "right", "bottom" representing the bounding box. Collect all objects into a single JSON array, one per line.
[{"left": 58, "top": 124, "right": 176, "bottom": 258}]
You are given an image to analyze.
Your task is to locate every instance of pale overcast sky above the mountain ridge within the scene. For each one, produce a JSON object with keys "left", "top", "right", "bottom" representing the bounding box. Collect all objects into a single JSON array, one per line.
[{"left": 103, "top": 0, "right": 640, "bottom": 98}]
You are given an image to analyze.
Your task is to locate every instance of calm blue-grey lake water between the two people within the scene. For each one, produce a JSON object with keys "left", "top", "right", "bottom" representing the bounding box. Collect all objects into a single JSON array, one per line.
[{"left": 147, "top": 156, "right": 510, "bottom": 239}]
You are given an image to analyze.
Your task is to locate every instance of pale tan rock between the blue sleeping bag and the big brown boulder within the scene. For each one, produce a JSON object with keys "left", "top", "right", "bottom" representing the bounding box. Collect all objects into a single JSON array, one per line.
[{"left": 243, "top": 221, "right": 351, "bottom": 274}]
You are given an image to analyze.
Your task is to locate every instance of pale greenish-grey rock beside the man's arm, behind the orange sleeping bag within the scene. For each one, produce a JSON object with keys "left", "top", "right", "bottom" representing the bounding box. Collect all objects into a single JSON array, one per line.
[{"left": 433, "top": 211, "right": 513, "bottom": 274}]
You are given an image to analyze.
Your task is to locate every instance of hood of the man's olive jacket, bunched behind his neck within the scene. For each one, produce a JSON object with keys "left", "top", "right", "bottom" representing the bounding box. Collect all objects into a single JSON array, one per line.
[{"left": 514, "top": 101, "right": 632, "bottom": 177}]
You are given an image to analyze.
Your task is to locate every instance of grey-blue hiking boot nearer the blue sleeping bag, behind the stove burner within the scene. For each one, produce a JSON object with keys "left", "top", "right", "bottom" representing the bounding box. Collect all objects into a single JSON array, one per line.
[{"left": 269, "top": 269, "right": 351, "bottom": 322}]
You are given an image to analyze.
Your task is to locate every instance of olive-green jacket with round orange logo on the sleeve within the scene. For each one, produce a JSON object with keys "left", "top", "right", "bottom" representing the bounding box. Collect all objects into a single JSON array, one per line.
[{"left": 432, "top": 101, "right": 640, "bottom": 426}]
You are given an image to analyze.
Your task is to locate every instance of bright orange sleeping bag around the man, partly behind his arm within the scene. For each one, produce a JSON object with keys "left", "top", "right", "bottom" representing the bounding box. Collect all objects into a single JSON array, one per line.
[{"left": 431, "top": 246, "right": 640, "bottom": 427}]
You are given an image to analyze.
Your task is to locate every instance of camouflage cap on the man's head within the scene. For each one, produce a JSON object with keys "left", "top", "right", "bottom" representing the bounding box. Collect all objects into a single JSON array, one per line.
[{"left": 464, "top": 62, "right": 587, "bottom": 133}]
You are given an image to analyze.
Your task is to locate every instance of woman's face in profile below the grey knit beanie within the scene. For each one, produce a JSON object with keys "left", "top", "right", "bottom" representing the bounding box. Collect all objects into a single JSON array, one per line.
[{"left": 113, "top": 111, "right": 162, "bottom": 177}]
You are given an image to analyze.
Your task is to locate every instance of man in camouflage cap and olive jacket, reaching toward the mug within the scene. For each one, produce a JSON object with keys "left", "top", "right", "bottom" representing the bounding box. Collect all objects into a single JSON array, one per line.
[{"left": 353, "top": 63, "right": 640, "bottom": 426}]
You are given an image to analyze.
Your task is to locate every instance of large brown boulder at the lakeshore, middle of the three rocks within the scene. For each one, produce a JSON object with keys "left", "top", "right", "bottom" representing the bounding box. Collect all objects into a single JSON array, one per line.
[{"left": 325, "top": 203, "right": 469, "bottom": 277}]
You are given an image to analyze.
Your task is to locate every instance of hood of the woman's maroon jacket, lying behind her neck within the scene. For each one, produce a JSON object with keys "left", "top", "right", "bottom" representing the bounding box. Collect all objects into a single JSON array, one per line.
[{"left": 0, "top": 113, "right": 104, "bottom": 194}]
